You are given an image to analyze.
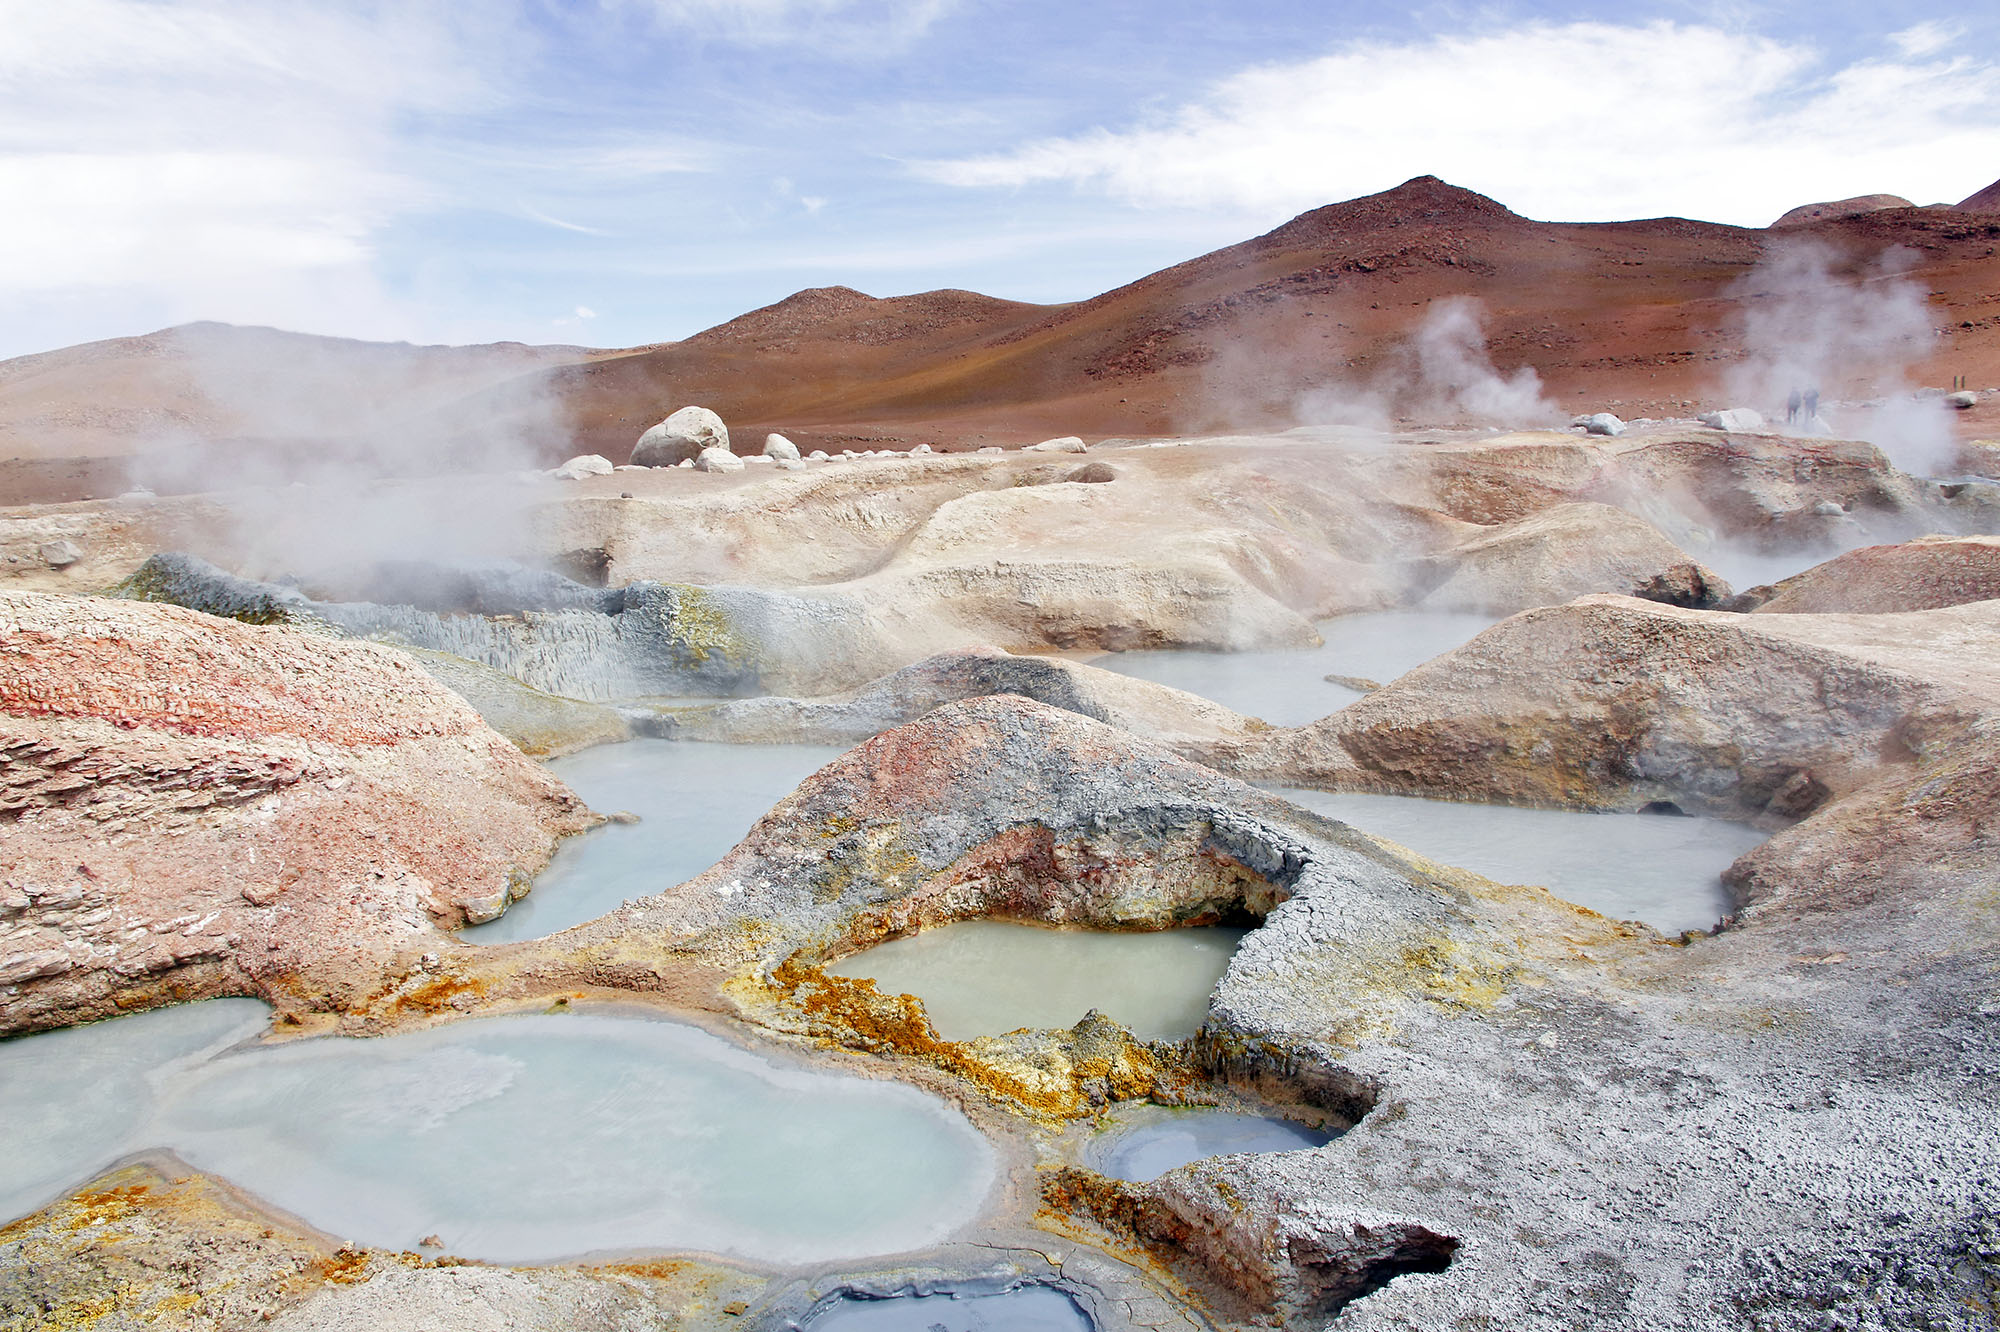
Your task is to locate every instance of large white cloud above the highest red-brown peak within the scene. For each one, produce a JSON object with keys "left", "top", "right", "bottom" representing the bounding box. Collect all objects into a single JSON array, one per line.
[{"left": 920, "top": 22, "right": 2000, "bottom": 226}]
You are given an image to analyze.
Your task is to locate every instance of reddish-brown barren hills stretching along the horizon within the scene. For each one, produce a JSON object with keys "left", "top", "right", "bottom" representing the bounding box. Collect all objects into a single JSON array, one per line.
[{"left": 0, "top": 176, "right": 2000, "bottom": 500}]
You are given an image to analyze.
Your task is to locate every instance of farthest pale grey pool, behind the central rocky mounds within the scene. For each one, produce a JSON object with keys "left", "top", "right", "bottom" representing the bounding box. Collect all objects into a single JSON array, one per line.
[{"left": 1090, "top": 610, "right": 1498, "bottom": 726}]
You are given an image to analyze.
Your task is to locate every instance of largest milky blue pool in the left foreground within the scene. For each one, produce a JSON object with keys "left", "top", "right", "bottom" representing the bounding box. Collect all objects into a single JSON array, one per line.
[{"left": 0, "top": 1002, "right": 998, "bottom": 1264}]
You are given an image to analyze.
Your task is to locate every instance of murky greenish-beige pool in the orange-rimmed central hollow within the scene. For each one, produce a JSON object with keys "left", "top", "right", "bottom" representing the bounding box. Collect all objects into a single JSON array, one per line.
[{"left": 826, "top": 920, "right": 1246, "bottom": 1040}]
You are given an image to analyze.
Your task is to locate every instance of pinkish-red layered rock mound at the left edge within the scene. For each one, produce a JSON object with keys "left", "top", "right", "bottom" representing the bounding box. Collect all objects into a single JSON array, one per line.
[{"left": 0, "top": 592, "right": 592, "bottom": 1032}]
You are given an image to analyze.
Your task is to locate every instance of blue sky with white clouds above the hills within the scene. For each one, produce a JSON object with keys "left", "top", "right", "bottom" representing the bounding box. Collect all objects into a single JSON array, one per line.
[{"left": 0, "top": 0, "right": 2000, "bottom": 356}]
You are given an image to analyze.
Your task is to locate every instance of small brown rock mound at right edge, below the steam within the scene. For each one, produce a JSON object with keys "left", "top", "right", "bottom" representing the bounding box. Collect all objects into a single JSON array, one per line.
[{"left": 1748, "top": 536, "right": 2000, "bottom": 614}]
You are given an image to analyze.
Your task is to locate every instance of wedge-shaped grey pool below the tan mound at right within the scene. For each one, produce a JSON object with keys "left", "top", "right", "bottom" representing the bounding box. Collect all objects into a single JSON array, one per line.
[{"left": 1270, "top": 786, "right": 1770, "bottom": 934}]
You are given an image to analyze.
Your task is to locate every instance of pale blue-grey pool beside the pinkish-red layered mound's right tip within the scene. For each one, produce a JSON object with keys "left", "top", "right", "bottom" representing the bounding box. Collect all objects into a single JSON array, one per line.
[{"left": 460, "top": 740, "right": 844, "bottom": 944}]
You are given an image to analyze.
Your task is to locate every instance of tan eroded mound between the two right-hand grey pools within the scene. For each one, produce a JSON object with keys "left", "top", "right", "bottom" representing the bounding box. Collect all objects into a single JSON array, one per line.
[{"left": 1238, "top": 596, "right": 2000, "bottom": 822}]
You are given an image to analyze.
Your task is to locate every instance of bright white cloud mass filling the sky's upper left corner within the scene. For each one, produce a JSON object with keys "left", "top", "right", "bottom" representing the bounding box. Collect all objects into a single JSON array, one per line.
[{"left": 0, "top": 0, "right": 506, "bottom": 330}]
